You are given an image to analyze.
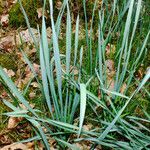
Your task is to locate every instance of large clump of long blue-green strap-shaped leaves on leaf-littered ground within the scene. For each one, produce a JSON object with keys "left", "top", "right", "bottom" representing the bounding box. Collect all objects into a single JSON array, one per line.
[{"left": 0, "top": 0, "right": 150, "bottom": 150}]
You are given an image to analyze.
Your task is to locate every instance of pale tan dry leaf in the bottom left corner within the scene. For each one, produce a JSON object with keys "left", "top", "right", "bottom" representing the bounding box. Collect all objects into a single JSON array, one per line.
[{"left": 1, "top": 143, "right": 28, "bottom": 150}]
